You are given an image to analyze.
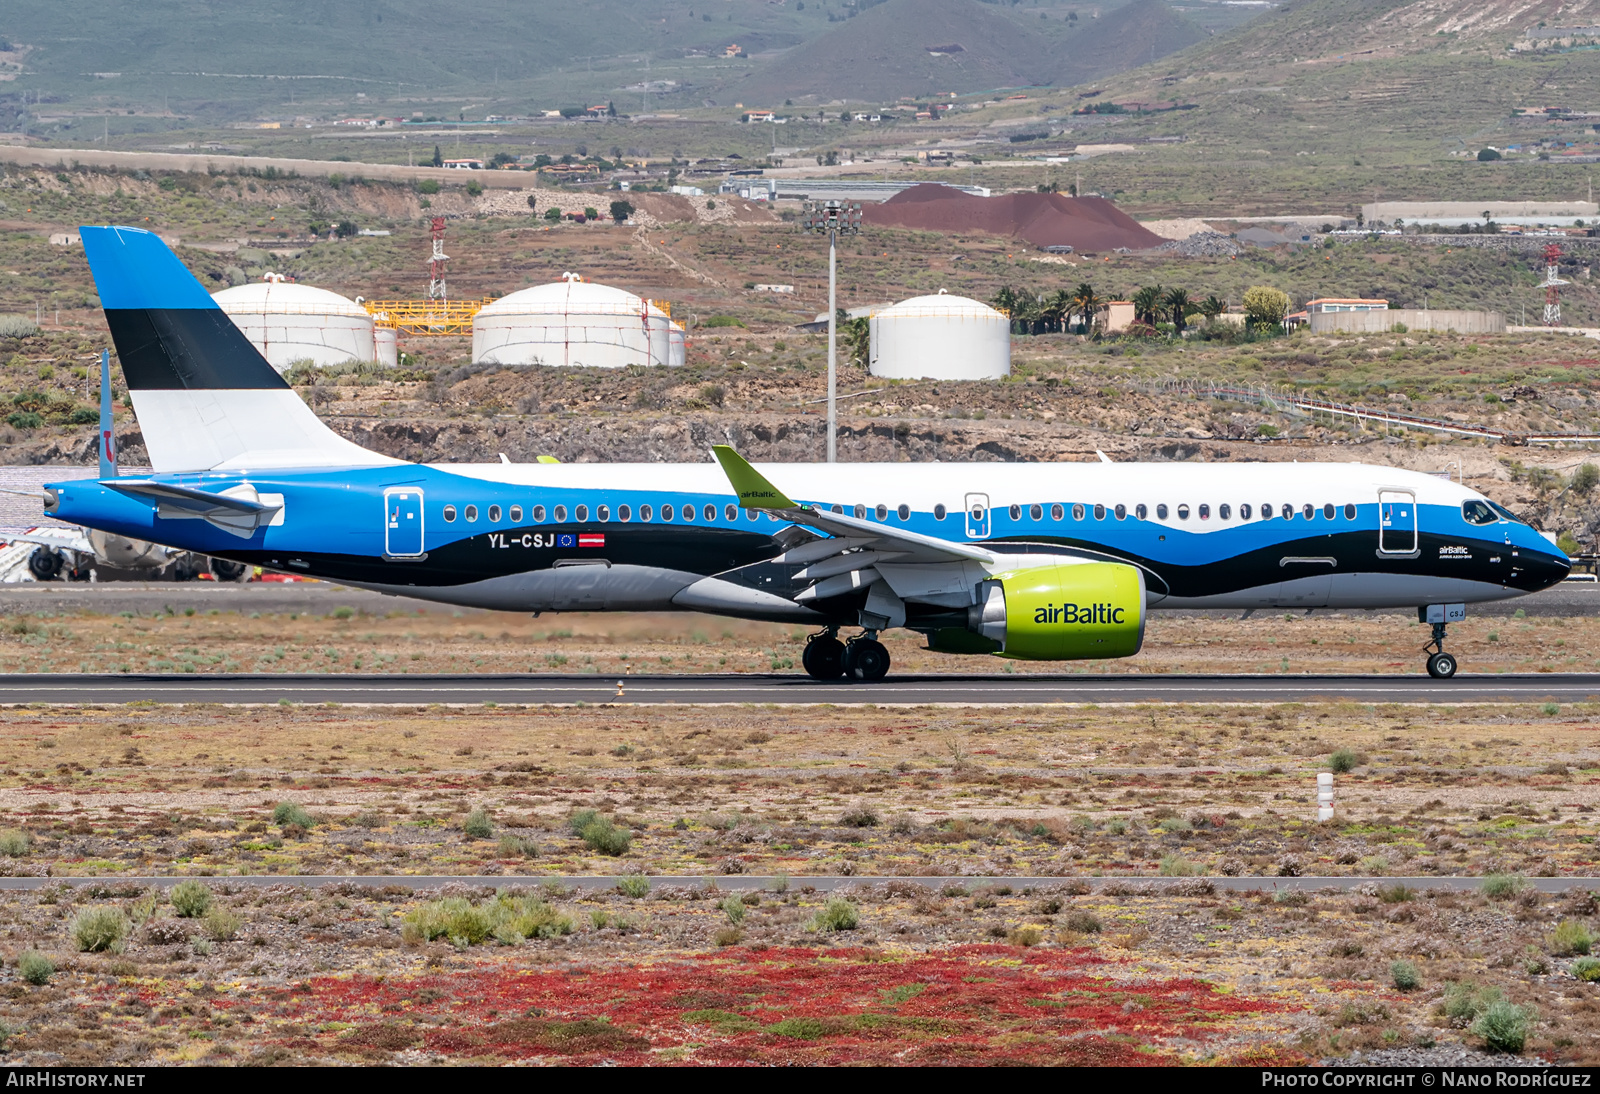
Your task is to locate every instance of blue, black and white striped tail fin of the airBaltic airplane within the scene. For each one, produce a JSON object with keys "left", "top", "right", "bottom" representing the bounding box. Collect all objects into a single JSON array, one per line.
[{"left": 82, "top": 227, "right": 398, "bottom": 472}]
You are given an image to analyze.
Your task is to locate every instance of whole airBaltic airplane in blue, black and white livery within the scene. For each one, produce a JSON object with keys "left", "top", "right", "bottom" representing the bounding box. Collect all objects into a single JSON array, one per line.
[{"left": 45, "top": 227, "right": 1568, "bottom": 680}]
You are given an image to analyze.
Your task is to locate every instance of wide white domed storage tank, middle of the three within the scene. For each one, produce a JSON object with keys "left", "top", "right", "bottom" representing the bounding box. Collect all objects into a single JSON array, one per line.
[{"left": 472, "top": 274, "right": 683, "bottom": 368}]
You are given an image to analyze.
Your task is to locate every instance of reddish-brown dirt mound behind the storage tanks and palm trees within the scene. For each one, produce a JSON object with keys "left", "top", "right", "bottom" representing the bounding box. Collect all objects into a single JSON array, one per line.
[{"left": 862, "top": 182, "right": 1166, "bottom": 253}]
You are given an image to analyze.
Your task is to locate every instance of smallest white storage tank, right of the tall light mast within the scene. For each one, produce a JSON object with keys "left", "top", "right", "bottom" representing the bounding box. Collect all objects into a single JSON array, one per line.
[{"left": 867, "top": 289, "right": 1011, "bottom": 379}]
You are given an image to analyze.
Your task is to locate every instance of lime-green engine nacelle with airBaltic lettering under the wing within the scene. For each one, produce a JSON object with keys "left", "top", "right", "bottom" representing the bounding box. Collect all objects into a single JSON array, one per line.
[{"left": 968, "top": 561, "right": 1144, "bottom": 661}]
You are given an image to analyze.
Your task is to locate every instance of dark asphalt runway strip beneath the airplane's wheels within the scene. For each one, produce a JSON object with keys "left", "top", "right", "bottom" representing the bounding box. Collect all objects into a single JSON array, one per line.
[{"left": 9, "top": 673, "right": 1600, "bottom": 705}]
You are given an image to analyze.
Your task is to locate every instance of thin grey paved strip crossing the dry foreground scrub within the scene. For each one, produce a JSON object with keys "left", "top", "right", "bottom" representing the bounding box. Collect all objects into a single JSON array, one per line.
[{"left": 0, "top": 873, "right": 1600, "bottom": 892}]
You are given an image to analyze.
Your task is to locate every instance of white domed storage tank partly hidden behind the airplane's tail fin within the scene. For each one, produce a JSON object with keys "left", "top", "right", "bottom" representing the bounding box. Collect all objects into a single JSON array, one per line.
[{"left": 211, "top": 274, "right": 378, "bottom": 373}]
